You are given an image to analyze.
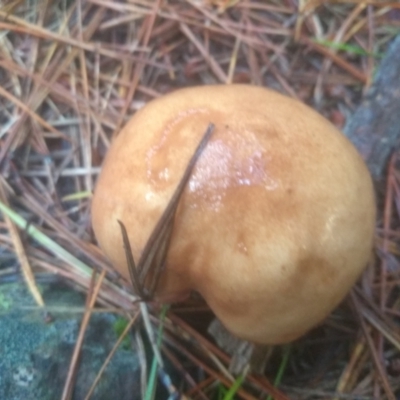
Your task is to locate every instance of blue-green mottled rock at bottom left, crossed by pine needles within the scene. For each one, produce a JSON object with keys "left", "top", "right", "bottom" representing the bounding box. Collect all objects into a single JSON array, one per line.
[{"left": 0, "top": 283, "right": 141, "bottom": 400}]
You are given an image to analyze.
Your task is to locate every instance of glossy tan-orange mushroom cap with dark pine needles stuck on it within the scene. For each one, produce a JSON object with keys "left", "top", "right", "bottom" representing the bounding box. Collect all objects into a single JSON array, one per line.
[{"left": 92, "top": 85, "right": 375, "bottom": 344}]
